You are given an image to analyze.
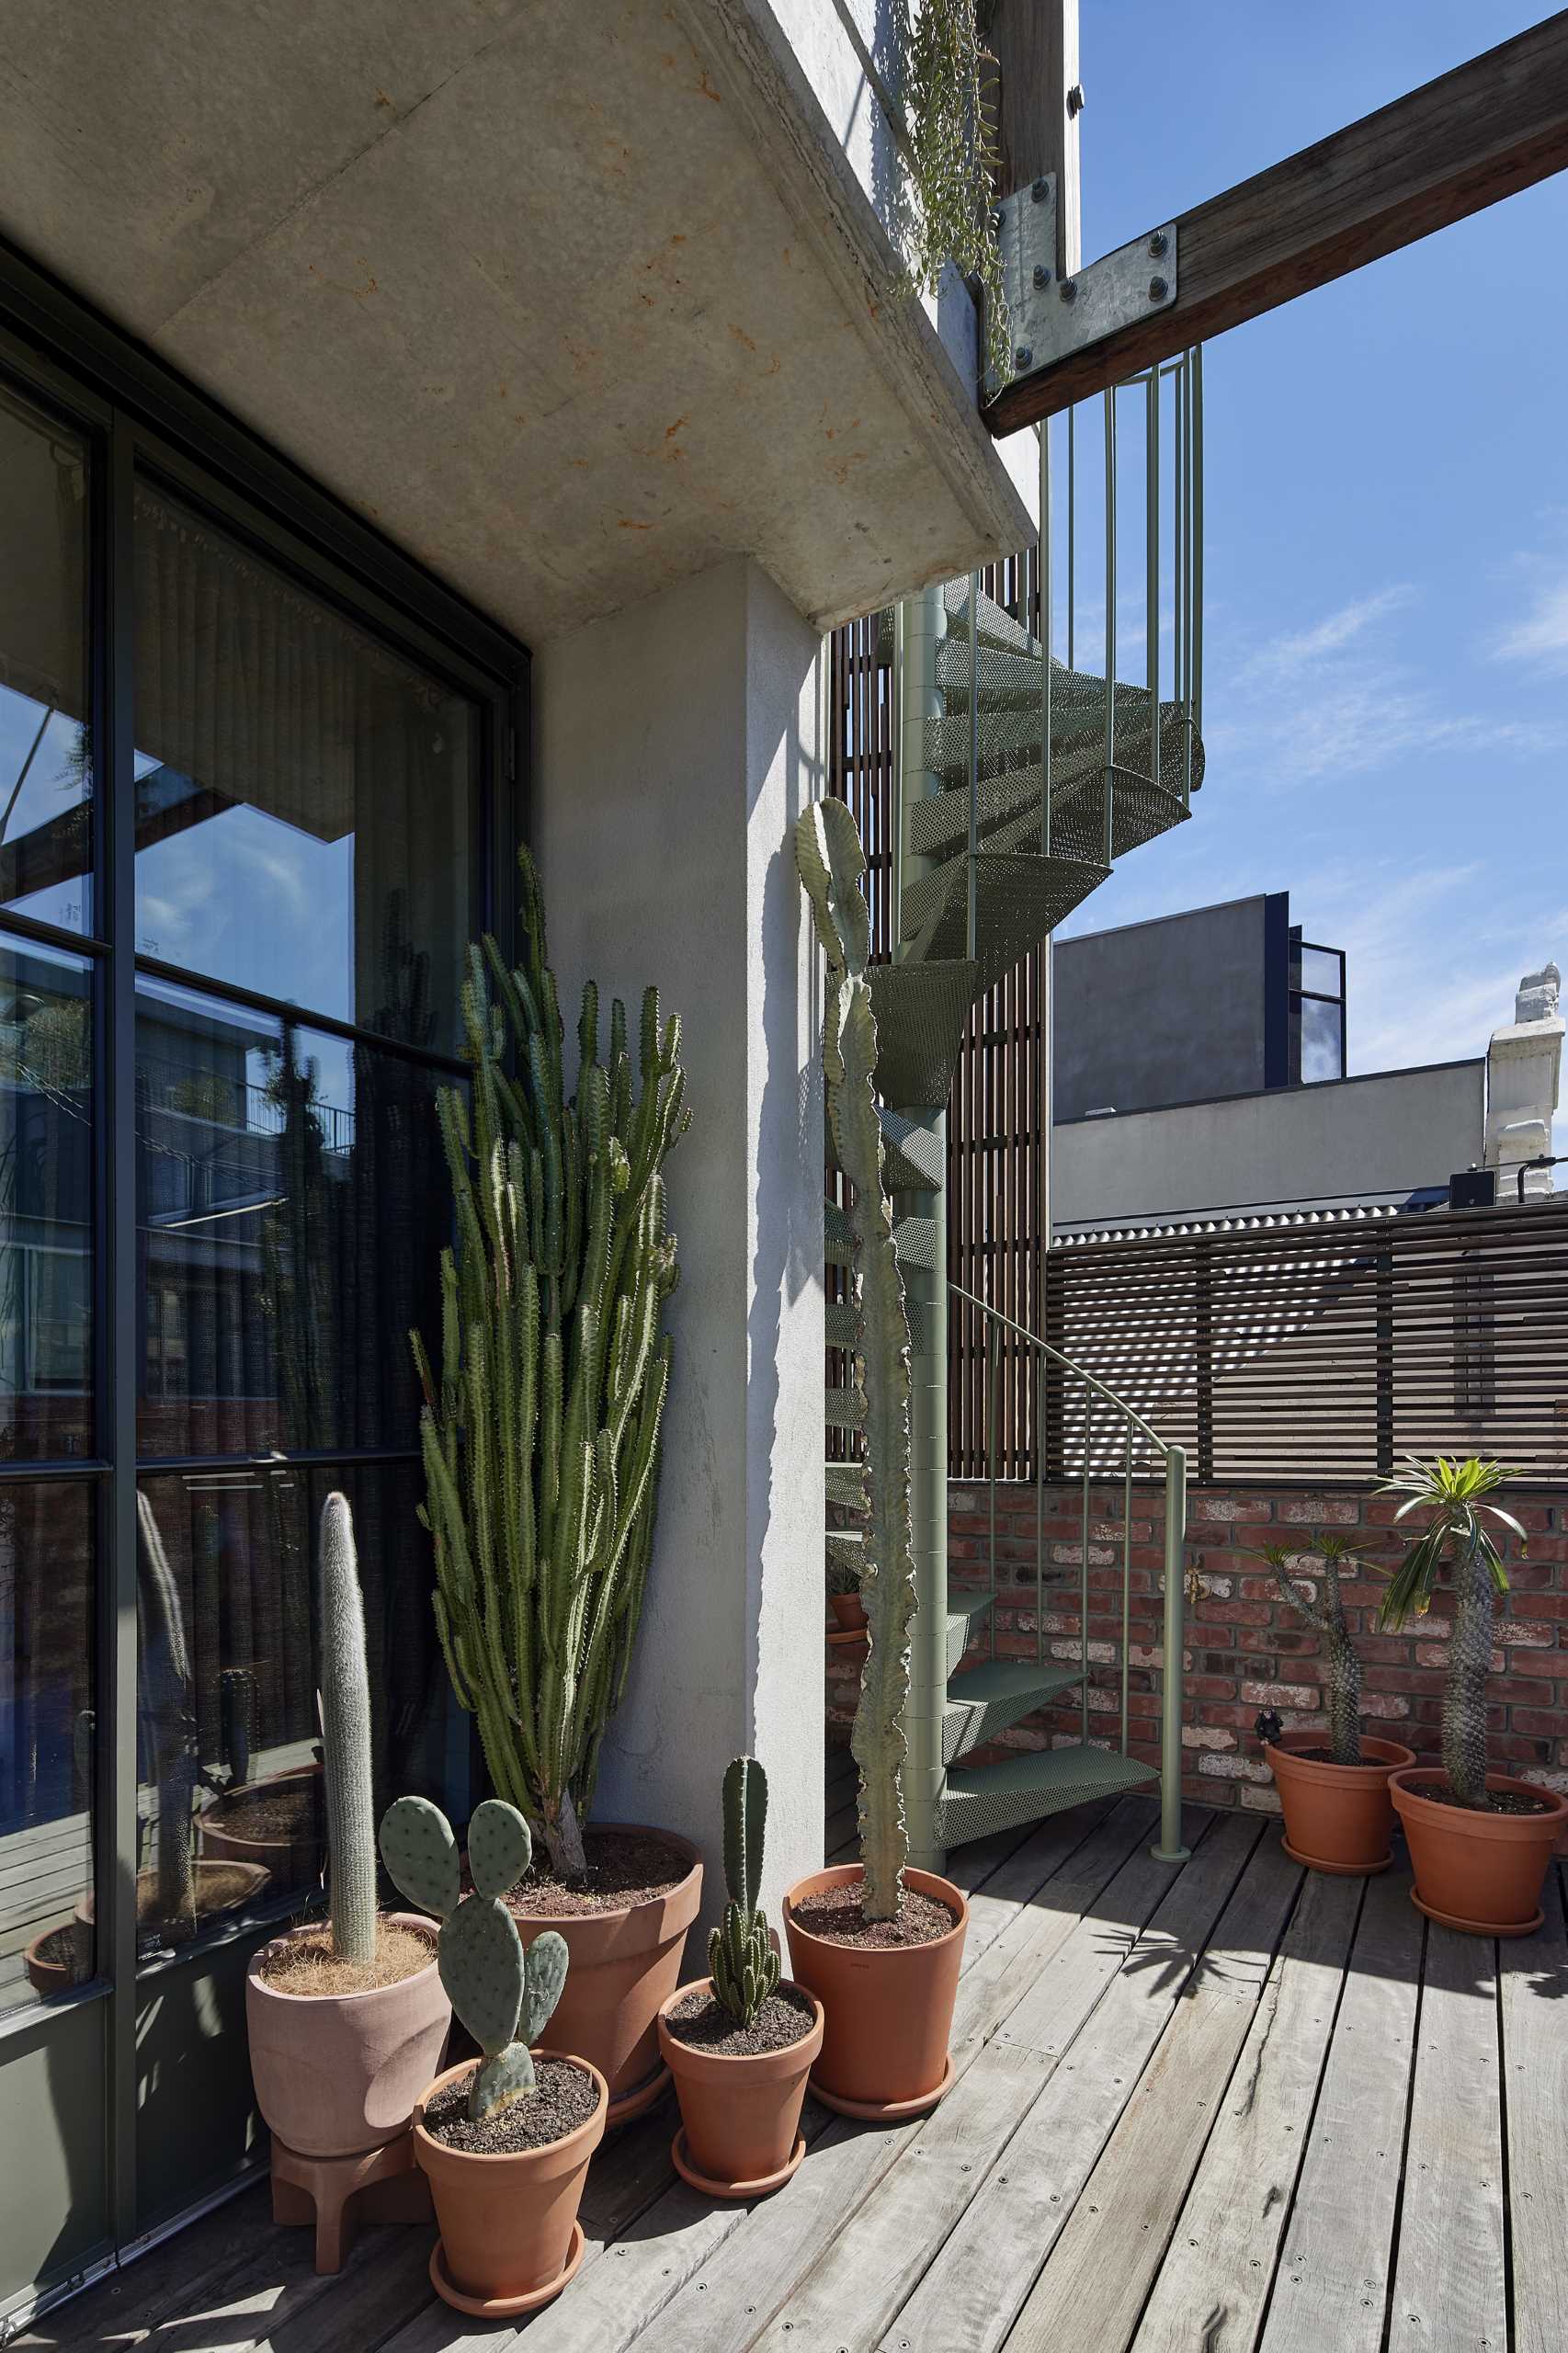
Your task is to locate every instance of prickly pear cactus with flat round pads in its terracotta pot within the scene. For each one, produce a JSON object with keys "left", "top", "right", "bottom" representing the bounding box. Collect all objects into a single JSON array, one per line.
[{"left": 381, "top": 1798, "right": 609, "bottom": 2320}]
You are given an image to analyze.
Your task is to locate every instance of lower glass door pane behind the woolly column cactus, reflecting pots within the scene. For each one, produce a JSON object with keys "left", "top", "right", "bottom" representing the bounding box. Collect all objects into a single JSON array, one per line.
[{"left": 139, "top": 1463, "right": 451, "bottom": 1953}]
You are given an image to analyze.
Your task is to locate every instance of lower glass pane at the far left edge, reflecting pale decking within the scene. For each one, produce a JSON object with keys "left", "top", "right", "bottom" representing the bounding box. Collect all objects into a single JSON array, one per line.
[{"left": 0, "top": 1480, "right": 94, "bottom": 2009}]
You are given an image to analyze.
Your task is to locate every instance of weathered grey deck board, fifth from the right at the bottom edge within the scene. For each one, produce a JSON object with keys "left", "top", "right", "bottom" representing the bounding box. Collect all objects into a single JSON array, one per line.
[{"left": 1007, "top": 1837, "right": 1304, "bottom": 2353}]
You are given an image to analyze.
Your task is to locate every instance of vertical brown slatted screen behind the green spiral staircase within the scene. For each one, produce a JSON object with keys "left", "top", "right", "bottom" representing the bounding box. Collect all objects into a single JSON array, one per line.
[{"left": 829, "top": 548, "right": 1043, "bottom": 1478}]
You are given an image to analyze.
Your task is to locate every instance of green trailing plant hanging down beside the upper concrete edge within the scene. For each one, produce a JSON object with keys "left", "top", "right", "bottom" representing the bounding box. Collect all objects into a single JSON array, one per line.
[{"left": 900, "top": 0, "right": 1012, "bottom": 383}]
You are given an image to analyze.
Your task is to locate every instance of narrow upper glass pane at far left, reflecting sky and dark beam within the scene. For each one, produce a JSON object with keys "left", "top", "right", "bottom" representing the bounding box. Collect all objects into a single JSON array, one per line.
[{"left": 0, "top": 386, "right": 92, "bottom": 932}]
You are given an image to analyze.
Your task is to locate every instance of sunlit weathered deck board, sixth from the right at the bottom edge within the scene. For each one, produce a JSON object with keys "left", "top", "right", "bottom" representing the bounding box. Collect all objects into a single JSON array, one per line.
[{"left": 883, "top": 1814, "right": 1262, "bottom": 2353}]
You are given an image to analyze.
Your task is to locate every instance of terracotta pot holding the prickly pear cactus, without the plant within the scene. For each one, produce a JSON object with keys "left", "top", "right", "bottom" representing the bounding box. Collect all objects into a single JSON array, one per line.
[{"left": 415, "top": 2050, "right": 609, "bottom": 2318}]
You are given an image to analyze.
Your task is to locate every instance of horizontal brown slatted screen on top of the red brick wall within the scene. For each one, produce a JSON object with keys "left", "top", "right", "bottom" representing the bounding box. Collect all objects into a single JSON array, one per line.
[{"left": 1045, "top": 1202, "right": 1568, "bottom": 1484}]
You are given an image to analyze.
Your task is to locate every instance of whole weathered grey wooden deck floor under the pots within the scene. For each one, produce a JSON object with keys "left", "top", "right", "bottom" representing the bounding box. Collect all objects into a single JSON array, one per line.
[{"left": 24, "top": 1768, "right": 1568, "bottom": 2353}]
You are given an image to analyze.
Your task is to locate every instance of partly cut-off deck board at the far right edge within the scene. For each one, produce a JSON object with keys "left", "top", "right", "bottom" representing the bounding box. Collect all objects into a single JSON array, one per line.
[{"left": 1500, "top": 1869, "right": 1568, "bottom": 2353}]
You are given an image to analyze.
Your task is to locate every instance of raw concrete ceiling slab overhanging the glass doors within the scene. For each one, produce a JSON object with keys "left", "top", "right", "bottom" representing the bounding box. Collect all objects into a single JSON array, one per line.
[{"left": 0, "top": 0, "right": 1028, "bottom": 644}]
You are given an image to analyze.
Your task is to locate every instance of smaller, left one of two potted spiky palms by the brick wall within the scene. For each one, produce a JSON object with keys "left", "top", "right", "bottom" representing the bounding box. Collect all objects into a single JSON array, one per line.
[{"left": 1259, "top": 1529, "right": 1415, "bottom": 1878}]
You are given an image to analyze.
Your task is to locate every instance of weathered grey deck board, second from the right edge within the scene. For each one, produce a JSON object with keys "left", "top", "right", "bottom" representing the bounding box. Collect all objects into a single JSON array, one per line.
[{"left": 1389, "top": 1925, "right": 1506, "bottom": 2353}]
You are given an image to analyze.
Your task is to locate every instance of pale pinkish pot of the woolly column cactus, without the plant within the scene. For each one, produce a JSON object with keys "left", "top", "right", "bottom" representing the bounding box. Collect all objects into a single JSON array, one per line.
[{"left": 244, "top": 1913, "right": 452, "bottom": 2158}]
